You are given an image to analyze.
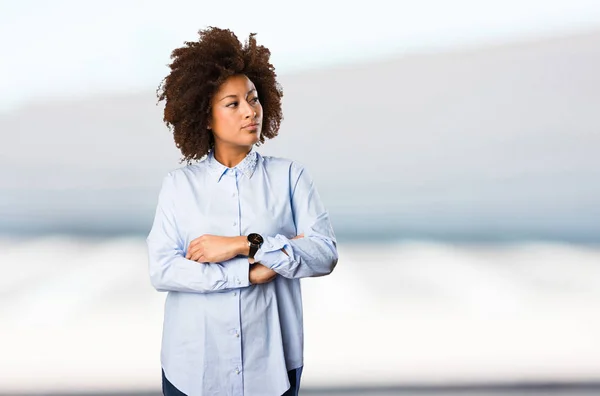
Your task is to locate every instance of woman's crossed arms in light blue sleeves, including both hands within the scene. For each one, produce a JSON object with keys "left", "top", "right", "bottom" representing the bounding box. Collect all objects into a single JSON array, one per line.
[{"left": 147, "top": 162, "right": 338, "bottom": 293}]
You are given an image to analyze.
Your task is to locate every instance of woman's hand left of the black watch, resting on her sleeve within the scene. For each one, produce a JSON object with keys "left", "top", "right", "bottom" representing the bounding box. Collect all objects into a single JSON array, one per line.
[{"left": 185, "top": 234, "right": 240, "bottom": 263}]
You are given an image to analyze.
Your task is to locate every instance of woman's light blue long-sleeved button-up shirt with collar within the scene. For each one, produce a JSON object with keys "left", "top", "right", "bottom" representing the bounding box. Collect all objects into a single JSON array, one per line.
[{"left": 147, "top": 149, "right": 338, "bottom": 396}]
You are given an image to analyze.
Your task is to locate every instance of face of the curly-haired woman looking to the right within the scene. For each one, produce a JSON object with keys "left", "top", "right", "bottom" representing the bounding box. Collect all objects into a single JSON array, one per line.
[{"left": 209, "top": 75, "right": 262, "bottom": 148}]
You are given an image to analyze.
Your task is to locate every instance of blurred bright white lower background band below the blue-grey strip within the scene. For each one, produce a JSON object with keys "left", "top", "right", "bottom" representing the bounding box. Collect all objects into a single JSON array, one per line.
[{"left": 0, "top": 235, "right": 600, "bottom": 394}]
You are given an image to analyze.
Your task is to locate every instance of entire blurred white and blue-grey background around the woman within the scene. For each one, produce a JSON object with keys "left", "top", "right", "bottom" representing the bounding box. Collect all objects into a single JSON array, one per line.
[{"left": 0, "top": 0, "right": 600, "bottom": 395}]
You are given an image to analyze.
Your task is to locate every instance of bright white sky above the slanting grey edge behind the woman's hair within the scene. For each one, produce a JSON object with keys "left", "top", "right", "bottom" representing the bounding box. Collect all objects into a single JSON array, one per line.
[{"left": 0, "top": 0, "right": 600, "bottom": 111}]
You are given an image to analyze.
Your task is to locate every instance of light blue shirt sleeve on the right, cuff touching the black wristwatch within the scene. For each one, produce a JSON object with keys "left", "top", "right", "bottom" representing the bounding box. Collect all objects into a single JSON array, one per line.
[{"left": 254, "top": 162, "right": 338, "bottom": 278}]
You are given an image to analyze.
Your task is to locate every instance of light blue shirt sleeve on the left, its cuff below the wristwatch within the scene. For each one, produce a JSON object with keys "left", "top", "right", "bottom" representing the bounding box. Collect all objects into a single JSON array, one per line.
[{"left": 146, "top": 173, "right": 250, "bottom": 293}]
